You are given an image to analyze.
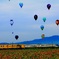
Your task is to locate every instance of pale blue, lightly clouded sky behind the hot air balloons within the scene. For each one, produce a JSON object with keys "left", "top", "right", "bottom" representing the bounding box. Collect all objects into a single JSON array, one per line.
[{"left": 0, "top": 0, "right": 59, "bottom": 42}]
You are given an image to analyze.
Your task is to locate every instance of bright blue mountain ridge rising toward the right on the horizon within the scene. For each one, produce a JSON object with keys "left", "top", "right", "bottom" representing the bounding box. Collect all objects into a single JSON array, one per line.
[{"left": 15, "top": 35, "right": 59, "bottom": 44}]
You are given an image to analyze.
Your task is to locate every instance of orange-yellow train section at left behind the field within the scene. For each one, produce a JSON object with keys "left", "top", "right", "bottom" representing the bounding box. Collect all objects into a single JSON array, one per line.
[{"left": 0, "top": 44, "right": 25, "bottom": 49}]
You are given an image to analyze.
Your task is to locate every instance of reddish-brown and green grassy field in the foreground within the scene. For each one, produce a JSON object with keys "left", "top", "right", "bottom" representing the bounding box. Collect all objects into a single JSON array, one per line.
[{"left": 0, "top": 48, "right": 59, "bottom": 59}]
